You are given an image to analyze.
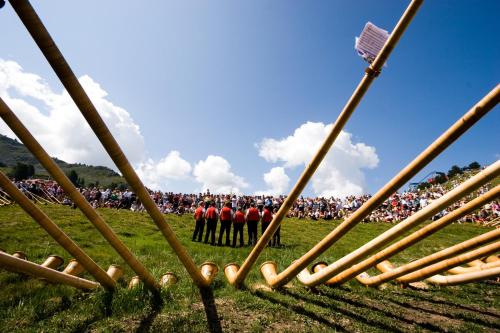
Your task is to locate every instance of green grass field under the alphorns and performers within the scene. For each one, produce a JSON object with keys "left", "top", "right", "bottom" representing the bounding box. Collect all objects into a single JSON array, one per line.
[{"left": 0, "top": 206, "right": 500, "bottom": 332}]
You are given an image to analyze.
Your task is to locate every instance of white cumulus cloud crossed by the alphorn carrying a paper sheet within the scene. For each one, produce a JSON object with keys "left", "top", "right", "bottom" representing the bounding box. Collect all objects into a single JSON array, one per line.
[{"left": 257, "top": 122, "right": 379, "bottom": 197}]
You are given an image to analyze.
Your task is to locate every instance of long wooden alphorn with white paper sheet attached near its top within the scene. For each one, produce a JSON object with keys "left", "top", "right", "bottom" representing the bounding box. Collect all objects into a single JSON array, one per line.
[{"left": 226, "top": 0, "right": 423, "bottom": 286}]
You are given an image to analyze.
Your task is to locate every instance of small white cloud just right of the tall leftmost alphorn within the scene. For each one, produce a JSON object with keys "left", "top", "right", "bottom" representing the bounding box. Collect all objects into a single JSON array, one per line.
[{"left": 136, "top": 150, "right": 192, "bottom": 190}]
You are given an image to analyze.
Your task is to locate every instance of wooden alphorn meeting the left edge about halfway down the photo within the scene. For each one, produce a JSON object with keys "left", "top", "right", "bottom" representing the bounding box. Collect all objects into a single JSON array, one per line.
[{"left": 0, "top": 172, "right": 116, "bottom": 289}]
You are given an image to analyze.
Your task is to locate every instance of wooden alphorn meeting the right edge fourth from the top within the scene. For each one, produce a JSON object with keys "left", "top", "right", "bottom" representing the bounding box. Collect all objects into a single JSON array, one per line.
[{"left": 356, "top": 229, "right": 500, "bottom": 287}]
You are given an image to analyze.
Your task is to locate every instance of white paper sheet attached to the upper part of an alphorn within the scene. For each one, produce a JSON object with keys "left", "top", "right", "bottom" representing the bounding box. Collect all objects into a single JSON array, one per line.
[{"left": 354, "top": 22, "right": 389, "bottom": 63}]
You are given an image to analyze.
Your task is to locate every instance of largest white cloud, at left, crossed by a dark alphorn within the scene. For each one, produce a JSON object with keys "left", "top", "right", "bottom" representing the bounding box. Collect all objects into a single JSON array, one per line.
[{"left": 0, "top": 59, "right": 144, "bottom": 167}]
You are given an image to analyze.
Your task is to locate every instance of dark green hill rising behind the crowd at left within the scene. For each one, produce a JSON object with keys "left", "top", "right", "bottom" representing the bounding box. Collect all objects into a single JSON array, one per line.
[{"left": 0, "top": 134, "right": 126, "bottom": 186}]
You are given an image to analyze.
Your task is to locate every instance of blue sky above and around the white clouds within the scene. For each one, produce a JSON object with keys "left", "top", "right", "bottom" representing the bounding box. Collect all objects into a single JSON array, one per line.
[{"left": 0, "top": 0, "right": 500, "bottom": 194}]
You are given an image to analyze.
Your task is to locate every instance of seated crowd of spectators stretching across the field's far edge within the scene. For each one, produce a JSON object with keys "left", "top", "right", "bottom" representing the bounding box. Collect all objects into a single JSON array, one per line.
[{"left": 5, "top": 170, "right": 500, "bottom": 223}]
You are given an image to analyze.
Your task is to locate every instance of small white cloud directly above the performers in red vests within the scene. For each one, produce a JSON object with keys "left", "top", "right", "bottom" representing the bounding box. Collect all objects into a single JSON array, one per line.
[{"left": 193, "top": 155, "right": 248, "bottom": 193}]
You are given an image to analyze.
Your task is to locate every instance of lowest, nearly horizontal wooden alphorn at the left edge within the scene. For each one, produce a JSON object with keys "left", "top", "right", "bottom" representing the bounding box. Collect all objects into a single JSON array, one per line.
[{"left": 0, "top": 251, "right": 100, "bottom": 289}]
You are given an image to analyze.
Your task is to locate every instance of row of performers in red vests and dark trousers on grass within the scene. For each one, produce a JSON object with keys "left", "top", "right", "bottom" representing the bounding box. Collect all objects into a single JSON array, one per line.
[{"left": 192, "top": 201, "right": 281, "bottom": 247}]
